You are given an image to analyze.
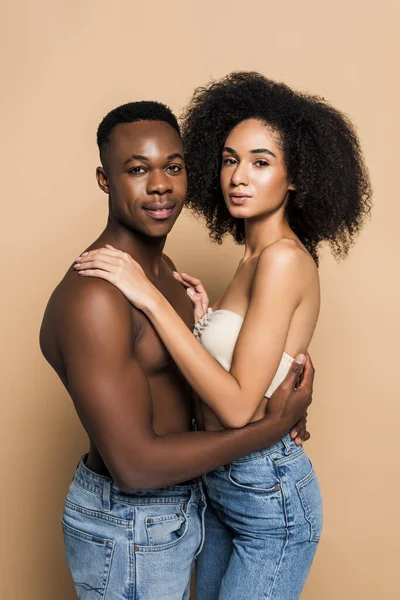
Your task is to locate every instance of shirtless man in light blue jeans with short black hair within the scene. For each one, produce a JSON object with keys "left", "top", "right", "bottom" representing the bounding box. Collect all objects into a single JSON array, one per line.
[{"left": 40, "top": 102, "right": 313, "bottom": 600}]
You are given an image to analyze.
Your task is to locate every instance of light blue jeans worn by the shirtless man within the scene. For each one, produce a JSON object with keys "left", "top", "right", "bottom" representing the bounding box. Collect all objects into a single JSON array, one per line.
[{"left": 62, "top": 457, "right": 206, "bottom": 600}]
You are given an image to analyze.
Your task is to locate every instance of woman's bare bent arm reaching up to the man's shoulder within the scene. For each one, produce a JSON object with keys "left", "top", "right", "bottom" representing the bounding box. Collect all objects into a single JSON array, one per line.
[{"left": 75, "top": 243, "right": 309, "bottom": 429}]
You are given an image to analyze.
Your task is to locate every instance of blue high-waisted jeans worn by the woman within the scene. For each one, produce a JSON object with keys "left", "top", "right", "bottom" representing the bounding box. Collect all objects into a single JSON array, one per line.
[{"left": 196, "top": 434, "right": 322, "bottom": 600}]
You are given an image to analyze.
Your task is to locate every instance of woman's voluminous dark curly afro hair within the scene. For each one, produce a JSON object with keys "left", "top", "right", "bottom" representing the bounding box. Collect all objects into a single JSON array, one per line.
[{"left": 181, "top": 72, "right": 371, "bottom": 263}]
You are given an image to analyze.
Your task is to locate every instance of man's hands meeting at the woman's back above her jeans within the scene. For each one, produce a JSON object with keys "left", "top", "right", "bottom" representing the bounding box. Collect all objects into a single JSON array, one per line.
[{"left": 266, "top": 354, "right": 315, "bottom": 445}]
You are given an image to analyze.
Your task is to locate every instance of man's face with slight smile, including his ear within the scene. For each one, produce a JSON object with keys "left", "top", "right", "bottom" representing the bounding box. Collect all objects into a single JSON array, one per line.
[{"left": 97, "top": 121, "right": 187, "bottom": 237}]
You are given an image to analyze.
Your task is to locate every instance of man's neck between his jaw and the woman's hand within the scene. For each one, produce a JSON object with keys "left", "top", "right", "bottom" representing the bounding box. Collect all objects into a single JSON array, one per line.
[{"left": 95, "top": 220, "right": 167, "bottom": 279}]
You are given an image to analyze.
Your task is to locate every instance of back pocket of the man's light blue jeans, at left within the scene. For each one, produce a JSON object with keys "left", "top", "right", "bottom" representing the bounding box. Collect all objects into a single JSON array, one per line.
[{"left": 62, "top": 519, "right": 114, "bottom": 600}]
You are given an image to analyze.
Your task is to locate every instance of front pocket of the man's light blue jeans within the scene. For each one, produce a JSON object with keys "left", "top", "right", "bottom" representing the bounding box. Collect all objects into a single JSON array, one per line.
[{"left": 140, "top": 505, "right": 189, "bottom": 550}]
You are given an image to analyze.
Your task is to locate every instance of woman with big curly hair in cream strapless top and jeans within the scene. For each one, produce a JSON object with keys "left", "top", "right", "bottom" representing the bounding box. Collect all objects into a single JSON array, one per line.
[{"left": 77, "top": 73, "right": 370, "bottom": 600}]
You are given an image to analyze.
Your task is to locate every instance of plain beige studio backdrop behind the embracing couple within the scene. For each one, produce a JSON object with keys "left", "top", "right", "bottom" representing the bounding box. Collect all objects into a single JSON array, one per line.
[{"left": 0, "top": 0, "right": 400, "bottom": 600}]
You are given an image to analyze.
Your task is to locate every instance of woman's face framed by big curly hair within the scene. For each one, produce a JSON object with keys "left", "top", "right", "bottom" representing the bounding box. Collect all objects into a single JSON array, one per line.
[{"left": 221, "top": 119, "right": 294, "bottom": 219}]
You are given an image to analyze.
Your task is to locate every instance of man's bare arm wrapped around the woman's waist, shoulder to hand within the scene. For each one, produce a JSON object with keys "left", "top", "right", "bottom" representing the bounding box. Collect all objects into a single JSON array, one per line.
[{"left": 59, "top": 282, "right": 312, "bottom": 490}]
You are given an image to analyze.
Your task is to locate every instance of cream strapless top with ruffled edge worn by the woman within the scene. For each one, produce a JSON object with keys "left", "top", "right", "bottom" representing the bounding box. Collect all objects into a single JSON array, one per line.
[{"left": 193, "top": 308, "right": 294, "bottom": 398}]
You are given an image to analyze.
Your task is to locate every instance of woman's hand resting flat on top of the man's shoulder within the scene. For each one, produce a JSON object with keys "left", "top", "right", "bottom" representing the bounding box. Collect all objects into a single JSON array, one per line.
[{"left": 74, "top": 245, "right": 159, "bottom": 311}]
